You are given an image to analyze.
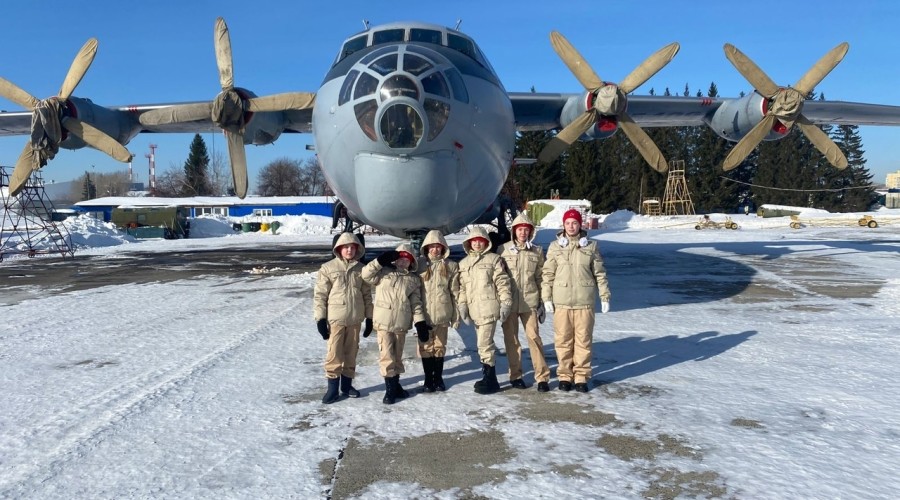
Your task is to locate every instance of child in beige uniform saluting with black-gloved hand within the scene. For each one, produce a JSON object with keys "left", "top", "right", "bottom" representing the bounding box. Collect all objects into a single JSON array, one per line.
[{"left": 362, "top": 243, "right": 428, "bottom": 404}]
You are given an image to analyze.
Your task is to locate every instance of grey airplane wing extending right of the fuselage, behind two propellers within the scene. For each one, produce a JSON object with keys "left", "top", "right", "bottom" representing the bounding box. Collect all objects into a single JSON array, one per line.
[{"left": 509, "top": 92, "right": 900, "bottom": 132}]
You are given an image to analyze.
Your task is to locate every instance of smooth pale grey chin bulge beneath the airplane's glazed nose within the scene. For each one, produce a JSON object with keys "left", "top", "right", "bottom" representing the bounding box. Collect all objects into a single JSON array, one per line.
[{"left": 353, "top": 151, "right": 458, "bottom": 232}]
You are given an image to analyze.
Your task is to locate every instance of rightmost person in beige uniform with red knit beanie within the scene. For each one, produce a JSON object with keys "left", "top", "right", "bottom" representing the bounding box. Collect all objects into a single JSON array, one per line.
[{"left": 541, "top": 210, "right": 610, "bottom": 392}]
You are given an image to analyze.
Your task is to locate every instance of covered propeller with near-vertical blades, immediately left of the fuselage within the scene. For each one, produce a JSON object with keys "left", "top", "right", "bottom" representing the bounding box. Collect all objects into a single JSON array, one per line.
[{"left": 140, "top": 17, "right": 316, "bottom": 198}]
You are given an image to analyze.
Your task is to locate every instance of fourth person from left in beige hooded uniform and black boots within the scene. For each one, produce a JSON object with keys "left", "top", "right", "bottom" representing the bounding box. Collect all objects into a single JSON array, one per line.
[{"left": 459, "top": 226, "right": 512, "bottom": 394}]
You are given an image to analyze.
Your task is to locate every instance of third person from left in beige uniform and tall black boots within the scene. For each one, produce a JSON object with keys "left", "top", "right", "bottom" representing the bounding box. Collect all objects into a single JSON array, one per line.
[{"left": 418, "top": 229, "right": 459, "bottom": 392}]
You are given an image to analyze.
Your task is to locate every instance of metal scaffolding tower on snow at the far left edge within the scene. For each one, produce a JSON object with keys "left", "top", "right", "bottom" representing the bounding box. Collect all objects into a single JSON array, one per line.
[{"left": 0, "top": 166, "right": 75, "bottom": 261}]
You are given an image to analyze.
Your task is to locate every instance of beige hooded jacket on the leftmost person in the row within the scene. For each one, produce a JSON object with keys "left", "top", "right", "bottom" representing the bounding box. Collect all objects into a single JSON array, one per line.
[{"left": 313, "top": 233, "right": 372, "bottom": 326}]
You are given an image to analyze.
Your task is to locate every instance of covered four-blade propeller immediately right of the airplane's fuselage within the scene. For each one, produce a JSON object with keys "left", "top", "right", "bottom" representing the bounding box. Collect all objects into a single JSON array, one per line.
[{"left": 538, "top": 31, "right": 680, "bottom": 172}]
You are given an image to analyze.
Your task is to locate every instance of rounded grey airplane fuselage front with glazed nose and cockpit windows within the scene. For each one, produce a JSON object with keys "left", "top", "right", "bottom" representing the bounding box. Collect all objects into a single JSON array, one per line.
[{"left": 312, "top": 23, "right": 515, "bottom": 237}]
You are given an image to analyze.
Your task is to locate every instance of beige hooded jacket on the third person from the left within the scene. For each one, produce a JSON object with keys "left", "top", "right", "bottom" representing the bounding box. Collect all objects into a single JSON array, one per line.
[{"left": 419, "top": 229, "right": 459, "bottom": 326}]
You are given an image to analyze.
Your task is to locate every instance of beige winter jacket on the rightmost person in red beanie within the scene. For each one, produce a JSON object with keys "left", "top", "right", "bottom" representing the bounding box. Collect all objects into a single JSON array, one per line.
[{"left": 541, "top": 231, "right": 610, "bottom": 309}]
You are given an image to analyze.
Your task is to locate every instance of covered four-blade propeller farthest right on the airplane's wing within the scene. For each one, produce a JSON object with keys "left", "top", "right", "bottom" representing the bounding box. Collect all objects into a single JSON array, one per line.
[{"left": 722, "top": 42, "right": 850, "bottom": 171}]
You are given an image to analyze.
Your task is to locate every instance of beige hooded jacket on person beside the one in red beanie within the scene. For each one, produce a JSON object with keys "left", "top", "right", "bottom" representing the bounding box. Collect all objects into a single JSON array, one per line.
[{"left": 500, "top": 212, "right": 544, "bottom": 313}]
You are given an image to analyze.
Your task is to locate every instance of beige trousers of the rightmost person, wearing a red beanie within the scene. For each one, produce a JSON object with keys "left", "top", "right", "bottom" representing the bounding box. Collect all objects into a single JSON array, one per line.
[{"left": 553, "top": 308, "right": 594, "bottom": 384}]
